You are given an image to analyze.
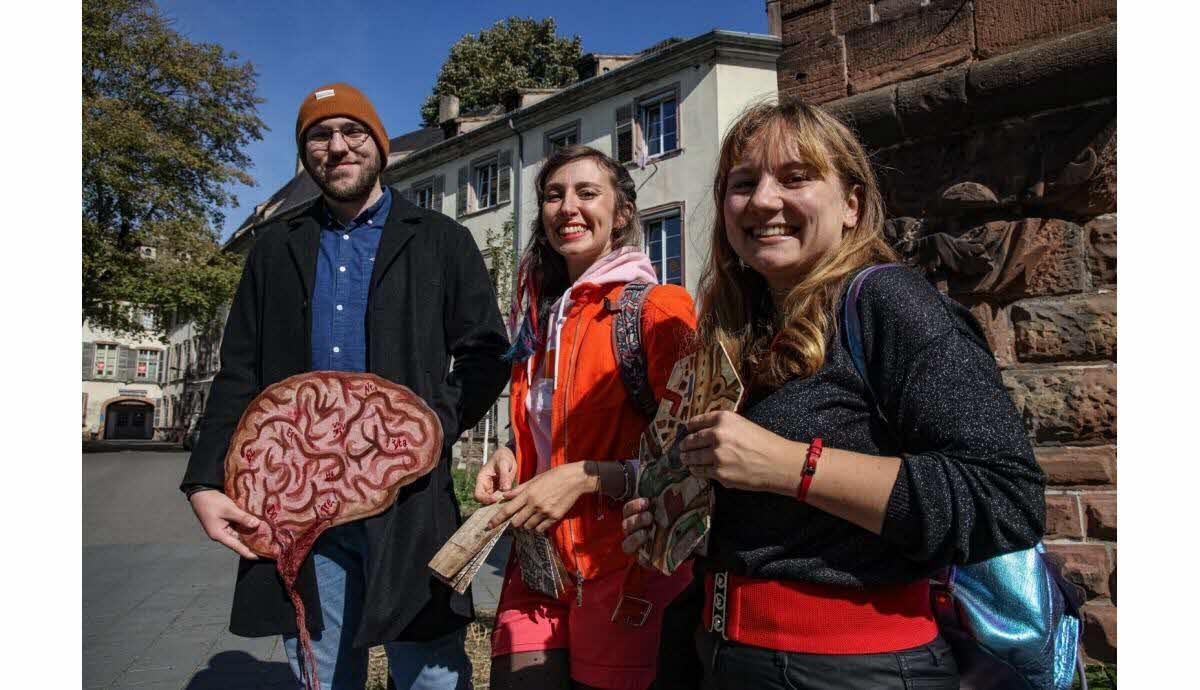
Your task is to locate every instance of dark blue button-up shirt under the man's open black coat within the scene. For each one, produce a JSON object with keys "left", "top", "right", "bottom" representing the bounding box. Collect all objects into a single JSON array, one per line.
[{"left": 312, "top": 187, "right": 391, "bottom": 371}]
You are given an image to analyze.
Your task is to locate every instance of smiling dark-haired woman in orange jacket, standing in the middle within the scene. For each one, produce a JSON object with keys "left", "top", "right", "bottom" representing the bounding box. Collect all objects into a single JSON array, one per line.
[{"left": 475, "top": 146, "right": 696, "bottom": 690}]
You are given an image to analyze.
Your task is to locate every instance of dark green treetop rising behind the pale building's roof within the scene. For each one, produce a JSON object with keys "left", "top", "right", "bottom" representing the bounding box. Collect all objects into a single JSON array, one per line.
[{"left": 421, "top": 17, "right": 580, "bottom": 126}]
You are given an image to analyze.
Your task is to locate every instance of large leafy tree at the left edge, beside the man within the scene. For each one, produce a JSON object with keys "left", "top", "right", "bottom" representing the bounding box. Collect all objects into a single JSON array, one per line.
[{"left": 83, "top": 0, "right": 266, "bottom": 334}]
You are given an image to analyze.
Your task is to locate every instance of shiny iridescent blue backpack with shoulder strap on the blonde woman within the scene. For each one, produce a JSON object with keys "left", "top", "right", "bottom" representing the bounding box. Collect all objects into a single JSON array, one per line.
[{"left": 841, "top": 264, "right": 1087, "bottom": 690}]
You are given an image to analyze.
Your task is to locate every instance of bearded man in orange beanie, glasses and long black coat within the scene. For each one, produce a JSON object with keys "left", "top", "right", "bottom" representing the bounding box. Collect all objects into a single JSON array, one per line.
[{"left": 180, "top": 84, "right": 509, "bottom": 690}]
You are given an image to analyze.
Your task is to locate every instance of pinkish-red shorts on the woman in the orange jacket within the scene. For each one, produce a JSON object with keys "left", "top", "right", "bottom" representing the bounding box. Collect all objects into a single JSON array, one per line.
[{"left": 492, "top": 558, "right": 691, "bottom": 690}]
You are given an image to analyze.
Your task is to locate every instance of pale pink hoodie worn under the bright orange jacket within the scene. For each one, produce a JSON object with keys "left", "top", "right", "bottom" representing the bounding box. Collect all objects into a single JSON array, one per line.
[{"left": 526, "top": 247, "right": 659, "bottom": 474}]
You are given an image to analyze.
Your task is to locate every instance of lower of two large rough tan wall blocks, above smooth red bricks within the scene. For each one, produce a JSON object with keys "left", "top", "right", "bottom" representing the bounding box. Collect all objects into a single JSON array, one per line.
[{"left": 1002, "top": 366, "right": 1117, "bottom": 444}]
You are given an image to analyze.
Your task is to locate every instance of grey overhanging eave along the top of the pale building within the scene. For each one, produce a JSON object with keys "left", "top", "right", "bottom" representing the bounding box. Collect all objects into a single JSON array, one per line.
[{"left": 383, "top": 29, "right": 782, "bottom": 181}]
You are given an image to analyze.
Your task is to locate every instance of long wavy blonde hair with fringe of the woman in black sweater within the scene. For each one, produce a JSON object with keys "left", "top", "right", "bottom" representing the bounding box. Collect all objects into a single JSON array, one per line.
[{"left": 698, "top": 100, "right": 896, "bottom": 389}]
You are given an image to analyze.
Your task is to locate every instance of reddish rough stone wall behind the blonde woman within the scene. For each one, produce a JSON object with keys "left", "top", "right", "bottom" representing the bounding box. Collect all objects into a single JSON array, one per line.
[{"left": 778, "top": 0, "right": 1117, "bottom": 662}]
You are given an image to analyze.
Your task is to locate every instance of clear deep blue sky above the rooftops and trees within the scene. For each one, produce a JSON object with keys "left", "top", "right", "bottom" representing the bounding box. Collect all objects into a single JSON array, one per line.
[{"left": 158, "top": 0, "right": 767, "bottom": 238}]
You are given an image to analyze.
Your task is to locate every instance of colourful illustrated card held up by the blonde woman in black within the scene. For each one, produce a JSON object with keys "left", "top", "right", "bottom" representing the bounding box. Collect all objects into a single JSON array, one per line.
[{"left": 637, "top": 344, "right": 742, "bottom": 574}]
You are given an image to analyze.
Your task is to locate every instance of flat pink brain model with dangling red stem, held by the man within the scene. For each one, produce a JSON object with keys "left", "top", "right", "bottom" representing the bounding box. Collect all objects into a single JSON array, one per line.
[{"left": 224, "top": 371, "right": 442, "bottom": 686}]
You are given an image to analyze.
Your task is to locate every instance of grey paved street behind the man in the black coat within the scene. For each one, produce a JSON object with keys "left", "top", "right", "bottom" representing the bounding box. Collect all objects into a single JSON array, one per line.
[{"left": 83, "top": 451, "right": 508, "bottom": 690}]
